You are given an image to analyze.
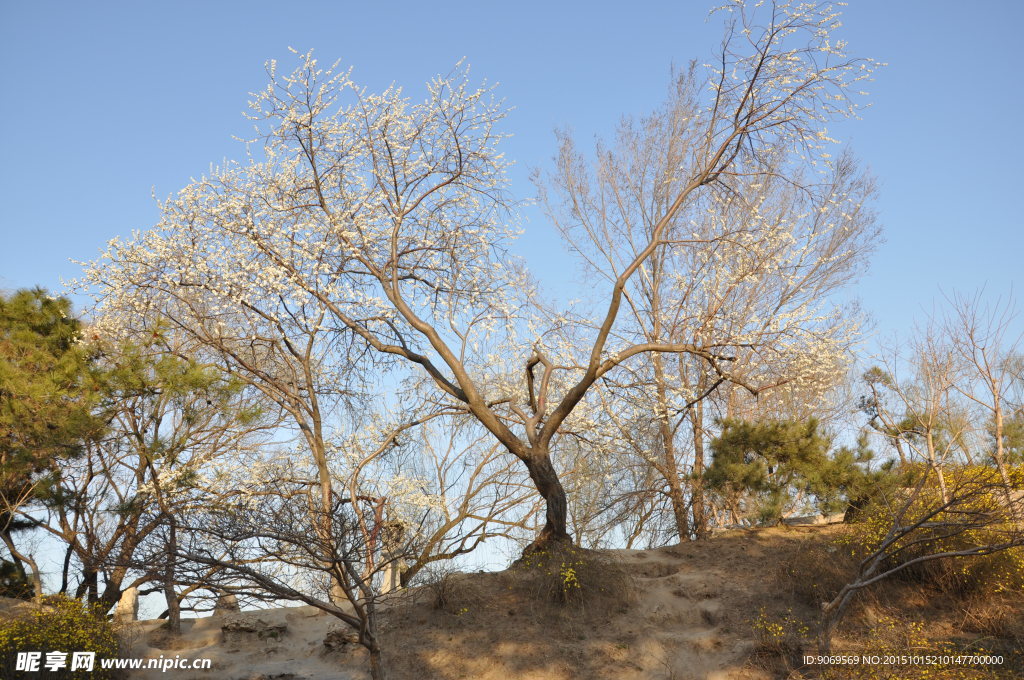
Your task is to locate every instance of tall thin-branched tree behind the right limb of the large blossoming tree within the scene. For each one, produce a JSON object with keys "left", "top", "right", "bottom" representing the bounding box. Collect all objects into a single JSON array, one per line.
[{"left": 540, "top": 98, "right": 878, "bottom": 537}]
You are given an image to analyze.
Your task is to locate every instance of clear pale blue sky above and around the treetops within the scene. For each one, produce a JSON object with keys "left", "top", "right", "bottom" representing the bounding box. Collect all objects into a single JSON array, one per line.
[{"left": 0, "top": 0, "right": 1024, "bottom": 340}]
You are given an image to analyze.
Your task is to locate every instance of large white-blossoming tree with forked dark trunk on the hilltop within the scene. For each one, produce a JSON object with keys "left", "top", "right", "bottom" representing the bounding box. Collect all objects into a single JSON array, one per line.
[{"left": 81, "top": 2, "right": 872, "bottom": 545}]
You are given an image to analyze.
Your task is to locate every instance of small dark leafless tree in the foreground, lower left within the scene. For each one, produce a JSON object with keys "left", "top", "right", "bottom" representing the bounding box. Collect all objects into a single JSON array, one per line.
[{"left": 174, "top": 480, "right": 385, "bottom": 680}]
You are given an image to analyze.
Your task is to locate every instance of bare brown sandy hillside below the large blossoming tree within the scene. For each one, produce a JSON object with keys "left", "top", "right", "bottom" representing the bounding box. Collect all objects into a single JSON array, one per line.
[{"left": 125, "top": 527, "right": 828, "bottom": 680}]
